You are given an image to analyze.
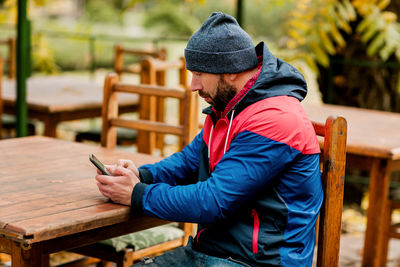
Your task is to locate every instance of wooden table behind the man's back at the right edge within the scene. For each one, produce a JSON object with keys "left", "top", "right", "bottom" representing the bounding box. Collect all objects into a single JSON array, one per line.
[{"left": 304, "top": 105, "right": 400, "bottom": 267}]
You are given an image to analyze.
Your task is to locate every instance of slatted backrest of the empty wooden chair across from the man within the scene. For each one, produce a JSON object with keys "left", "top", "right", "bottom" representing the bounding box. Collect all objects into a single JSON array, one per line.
[{"left": 101, "top": 73, "right": 197, "bottom": 154}]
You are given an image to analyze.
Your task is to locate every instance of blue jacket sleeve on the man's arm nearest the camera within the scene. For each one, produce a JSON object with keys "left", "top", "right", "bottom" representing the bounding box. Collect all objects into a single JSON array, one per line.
[{"left": 134, "top": 131, "right": 300, "bottom": 223}]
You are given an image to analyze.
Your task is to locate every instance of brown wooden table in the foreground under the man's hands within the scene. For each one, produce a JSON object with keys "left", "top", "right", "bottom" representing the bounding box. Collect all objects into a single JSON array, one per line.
[{"left": 0, "top": 136, "right": 165, "bottom": 266}]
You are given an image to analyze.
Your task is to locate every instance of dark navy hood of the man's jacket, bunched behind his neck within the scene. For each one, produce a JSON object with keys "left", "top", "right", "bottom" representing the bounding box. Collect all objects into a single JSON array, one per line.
[{"left": 203, "top": 42, "right": 307, "bottom": 119}]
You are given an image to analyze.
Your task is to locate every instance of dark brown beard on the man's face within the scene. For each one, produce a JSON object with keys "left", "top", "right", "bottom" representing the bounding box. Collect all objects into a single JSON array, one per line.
[{"left": 199, "top": 75, "right": 237, "bottom": 111}]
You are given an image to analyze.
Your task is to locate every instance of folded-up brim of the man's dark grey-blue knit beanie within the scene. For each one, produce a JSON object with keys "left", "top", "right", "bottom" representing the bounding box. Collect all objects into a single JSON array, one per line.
[{"left": 185, "top": 47, "right": 257, "bottom": 74}]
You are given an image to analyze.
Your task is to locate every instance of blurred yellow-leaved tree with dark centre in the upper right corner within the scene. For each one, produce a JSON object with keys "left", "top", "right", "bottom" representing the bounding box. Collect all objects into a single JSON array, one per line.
[{"left": 285, "top": 0, "right": 400, "bottom": 112}]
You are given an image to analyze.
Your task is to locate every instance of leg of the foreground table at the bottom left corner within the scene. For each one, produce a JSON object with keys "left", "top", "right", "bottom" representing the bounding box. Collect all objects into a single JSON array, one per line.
[{"left": 11, "top": 242, "right": 49, "bottom": 267}]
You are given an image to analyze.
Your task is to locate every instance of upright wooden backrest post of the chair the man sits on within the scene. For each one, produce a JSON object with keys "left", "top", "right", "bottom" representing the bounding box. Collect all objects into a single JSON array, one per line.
[{"left": 313, "top": 117, "right": 347, "bottom": 267}]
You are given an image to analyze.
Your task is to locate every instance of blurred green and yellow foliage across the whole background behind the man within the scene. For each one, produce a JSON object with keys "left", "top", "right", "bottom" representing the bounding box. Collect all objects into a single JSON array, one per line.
[{"left": 0, "top": 0, "right": 400, "bottom": 112}]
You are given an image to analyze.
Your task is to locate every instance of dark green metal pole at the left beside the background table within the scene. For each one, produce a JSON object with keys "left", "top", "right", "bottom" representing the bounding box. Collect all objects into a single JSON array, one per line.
[{"left": 15, "top": 0, "right": 30, "bottom": 137}]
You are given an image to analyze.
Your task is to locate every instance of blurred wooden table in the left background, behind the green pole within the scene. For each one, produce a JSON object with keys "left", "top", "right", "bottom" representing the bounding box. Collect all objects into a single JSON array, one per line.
[{"left": 2, "top": 76, "right": 139, "bottom": 137}]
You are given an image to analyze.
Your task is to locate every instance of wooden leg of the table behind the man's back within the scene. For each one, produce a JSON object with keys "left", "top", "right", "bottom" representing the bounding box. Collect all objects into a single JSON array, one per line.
[{"left": 362, "top": 159, "right": 390, "bottom": 267}]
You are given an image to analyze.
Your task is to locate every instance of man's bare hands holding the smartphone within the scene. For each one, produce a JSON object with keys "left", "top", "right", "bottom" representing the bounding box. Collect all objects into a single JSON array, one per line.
[{"left": 95, "top": 160, "right": 140, "bottom": 206}]
